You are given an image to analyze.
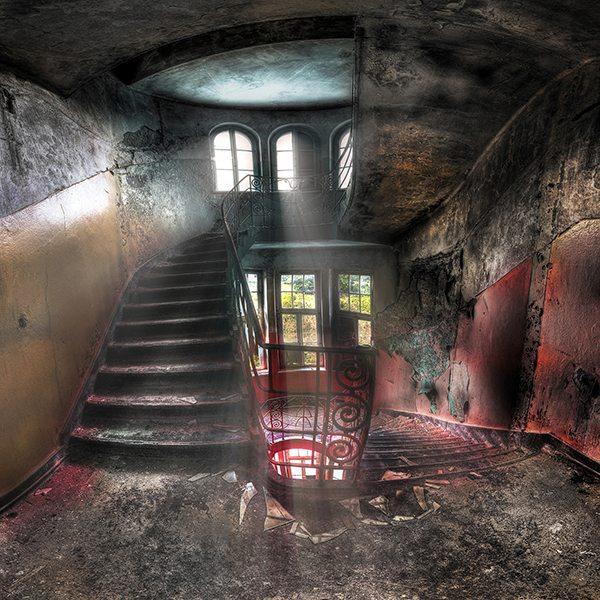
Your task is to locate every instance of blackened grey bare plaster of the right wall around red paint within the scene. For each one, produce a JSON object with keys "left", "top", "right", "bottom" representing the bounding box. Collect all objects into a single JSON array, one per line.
[{"left": 376, "top": 61, "right": 600, "bottom": 450}]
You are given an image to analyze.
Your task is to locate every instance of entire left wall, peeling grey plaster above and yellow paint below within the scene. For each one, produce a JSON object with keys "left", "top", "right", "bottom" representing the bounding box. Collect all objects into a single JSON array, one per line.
[{"left": 0, "top": 73, "right": 220, "bottom": 497}]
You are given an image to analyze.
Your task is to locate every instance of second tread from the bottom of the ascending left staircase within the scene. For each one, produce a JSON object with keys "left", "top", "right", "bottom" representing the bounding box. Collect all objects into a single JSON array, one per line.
[{"left": 86, "top": 392, "right": 243, "bottom": 408}]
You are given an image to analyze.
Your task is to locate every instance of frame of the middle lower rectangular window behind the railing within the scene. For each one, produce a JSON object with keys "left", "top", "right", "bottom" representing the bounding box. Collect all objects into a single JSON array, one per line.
[{"left": 274, "top": 269, "right": 323, "bottom": 370}]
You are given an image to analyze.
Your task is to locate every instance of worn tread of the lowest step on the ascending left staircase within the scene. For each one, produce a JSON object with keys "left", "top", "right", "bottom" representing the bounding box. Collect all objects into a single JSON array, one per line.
[{"left": 73, "top": 418, "right": 250, "bottom": 447}]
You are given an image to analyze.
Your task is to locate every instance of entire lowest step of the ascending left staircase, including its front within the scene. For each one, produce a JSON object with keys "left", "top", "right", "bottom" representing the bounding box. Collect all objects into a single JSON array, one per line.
[{"left": 71, "top": 417, "right": 250, "bottom": 455}]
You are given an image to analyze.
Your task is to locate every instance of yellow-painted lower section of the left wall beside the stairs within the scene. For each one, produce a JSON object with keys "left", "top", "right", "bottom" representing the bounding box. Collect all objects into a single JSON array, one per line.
[{"left": 0, "top": 173, "right": 128, "bottom": 497}]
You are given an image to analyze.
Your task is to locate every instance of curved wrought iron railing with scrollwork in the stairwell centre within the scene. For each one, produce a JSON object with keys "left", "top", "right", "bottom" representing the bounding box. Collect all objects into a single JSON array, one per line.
[{"left": 216, "top": 143, "right": 375, "bottom": 481}]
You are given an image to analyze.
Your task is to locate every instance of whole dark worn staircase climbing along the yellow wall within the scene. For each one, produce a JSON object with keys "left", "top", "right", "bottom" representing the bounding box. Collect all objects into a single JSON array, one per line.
[{"left": 71, "top": 235, "right": 250, "bottom": 459}]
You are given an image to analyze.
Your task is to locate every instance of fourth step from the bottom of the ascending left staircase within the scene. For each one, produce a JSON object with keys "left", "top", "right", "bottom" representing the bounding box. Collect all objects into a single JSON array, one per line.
[{"left": 106, "top": 335, "right": 232, "bottom": 365}]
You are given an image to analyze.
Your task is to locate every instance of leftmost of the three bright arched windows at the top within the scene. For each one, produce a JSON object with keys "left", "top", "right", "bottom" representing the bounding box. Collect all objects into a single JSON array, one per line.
[{"left": 212, "top": 128, "right": 258, "bottom": 192}]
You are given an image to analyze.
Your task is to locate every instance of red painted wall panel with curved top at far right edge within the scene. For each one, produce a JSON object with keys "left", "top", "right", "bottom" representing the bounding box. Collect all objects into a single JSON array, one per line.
[{"left": 527, "top": 220, "right": 600, "bottom": 460}]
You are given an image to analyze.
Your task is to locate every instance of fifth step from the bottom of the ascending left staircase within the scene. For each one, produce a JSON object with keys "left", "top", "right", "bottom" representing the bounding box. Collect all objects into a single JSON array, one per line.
[{"left": 114, "top": 314, "right": 229, "bottom": 341}]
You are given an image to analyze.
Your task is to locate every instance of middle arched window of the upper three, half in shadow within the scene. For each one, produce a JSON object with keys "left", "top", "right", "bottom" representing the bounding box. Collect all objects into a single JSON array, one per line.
[{"left": 273, "top": 129, "right": 318, "bottom": 190}]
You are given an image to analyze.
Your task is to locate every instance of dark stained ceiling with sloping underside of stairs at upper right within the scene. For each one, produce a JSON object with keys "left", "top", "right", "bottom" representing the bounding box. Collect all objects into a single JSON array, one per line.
[{"left": 0, "top": 0, "right": 600, "bottom": 234}]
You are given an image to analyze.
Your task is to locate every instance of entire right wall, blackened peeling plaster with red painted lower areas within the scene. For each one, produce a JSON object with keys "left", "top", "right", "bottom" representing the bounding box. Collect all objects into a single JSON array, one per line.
[{"left": 375, "top": 61, "right": 600, "bottom": 458}]
